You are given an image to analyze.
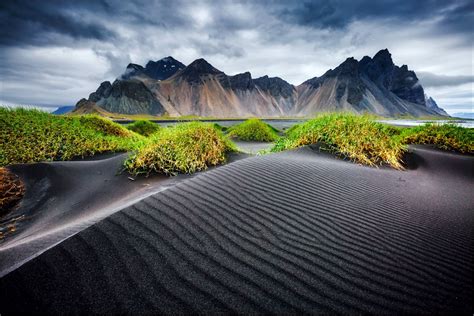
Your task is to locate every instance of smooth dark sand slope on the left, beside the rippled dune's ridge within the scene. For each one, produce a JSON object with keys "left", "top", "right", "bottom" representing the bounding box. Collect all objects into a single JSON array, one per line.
[{"left": 0, "top": 154, "right": 181, "bottom": 276}]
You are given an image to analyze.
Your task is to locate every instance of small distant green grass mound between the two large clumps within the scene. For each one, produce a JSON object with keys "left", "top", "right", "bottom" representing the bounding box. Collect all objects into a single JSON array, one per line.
[{"left": 228, "top": 119, "right": 278, "bottom": 142}]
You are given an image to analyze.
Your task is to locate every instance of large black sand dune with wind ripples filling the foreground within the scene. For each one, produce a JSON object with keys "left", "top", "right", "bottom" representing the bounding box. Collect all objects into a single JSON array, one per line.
[{"left": 0, "top": 147, "right": 474, "bottom": 315}]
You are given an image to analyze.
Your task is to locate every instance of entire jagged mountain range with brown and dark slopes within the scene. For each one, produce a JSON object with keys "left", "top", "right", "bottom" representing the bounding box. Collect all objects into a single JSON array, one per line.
[{"left": 74, "top": 49, "right": 448, "bottom": 117}]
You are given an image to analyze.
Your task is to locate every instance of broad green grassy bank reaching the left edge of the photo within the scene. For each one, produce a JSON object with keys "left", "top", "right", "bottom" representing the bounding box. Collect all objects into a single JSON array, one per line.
[{"left": 0, "top": 107, "right": 144, "bottom": 166}]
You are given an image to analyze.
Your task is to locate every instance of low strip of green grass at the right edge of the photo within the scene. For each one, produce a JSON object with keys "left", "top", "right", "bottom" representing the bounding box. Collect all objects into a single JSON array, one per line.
[{"left": 400, "top": 123, "right": 474, "bottom": 154}]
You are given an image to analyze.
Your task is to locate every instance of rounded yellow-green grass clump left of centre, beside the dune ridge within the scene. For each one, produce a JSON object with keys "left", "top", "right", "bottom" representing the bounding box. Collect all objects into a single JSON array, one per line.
[{"left": 125, "top": 122, "right": 236, "bottom": 175}]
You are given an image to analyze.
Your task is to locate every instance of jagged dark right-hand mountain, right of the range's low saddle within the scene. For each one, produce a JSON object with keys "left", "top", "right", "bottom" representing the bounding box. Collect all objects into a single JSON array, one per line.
[{"left": 294, "top": 49, "right": 439, "bottom": 116}]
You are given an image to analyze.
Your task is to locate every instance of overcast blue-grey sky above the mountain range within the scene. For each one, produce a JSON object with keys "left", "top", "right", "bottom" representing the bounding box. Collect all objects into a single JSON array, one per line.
[{"left": 0, "top": 0, "right": 474, "bottom": 113}]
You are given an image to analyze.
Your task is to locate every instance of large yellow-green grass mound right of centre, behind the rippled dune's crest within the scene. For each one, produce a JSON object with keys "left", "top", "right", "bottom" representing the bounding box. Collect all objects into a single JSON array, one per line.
[{"left": 271, "top": 113, "right": 405, "bottom": 169}]
